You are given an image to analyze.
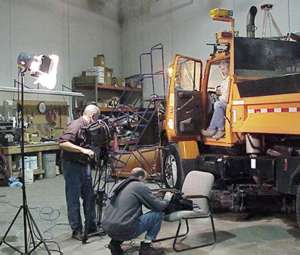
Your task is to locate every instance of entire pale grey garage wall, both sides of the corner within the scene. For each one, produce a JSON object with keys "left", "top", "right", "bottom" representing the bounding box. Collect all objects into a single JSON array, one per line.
[{"left": 0, "top": 0, "right": 300, "bottom": 100}]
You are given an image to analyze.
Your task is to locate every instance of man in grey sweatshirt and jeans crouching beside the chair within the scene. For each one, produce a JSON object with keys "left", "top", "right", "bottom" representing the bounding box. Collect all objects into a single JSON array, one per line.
[{"left": 102, "top": 168, "right": 168, "bottom": 255}]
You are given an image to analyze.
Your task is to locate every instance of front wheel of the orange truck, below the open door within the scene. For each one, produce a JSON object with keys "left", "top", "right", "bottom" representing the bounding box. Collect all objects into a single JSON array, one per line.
[{"left": 163, "top": 145, "right": 183, "bottom": 189}]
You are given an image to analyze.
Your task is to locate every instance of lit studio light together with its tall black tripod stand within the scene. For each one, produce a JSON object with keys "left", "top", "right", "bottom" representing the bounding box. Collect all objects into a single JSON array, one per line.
[{"left": 0, "top": 53, "right": 58, "bottom": 255}]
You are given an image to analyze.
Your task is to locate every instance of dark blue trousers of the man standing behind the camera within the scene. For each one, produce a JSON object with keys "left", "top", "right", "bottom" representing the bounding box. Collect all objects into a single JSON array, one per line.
[{"left": 62, "top": 160, "right": 96, "bottom": 232}]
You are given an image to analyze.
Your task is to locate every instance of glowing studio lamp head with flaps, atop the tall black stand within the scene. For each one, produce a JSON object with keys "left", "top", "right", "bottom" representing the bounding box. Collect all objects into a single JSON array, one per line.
[{"left": 17, "top": 52, "right": 59, "bottom": 89}]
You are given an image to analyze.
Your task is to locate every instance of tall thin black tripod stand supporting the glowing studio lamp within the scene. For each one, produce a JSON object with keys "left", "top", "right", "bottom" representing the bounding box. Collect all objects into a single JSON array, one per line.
[{"left": 0, "top": 69, "right": 51, "bottom": 255}]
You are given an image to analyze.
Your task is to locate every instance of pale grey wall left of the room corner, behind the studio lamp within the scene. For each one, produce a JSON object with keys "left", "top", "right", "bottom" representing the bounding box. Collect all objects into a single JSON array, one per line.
[{"left": 0, "top": 0, "right": 121, "bottom": 100}]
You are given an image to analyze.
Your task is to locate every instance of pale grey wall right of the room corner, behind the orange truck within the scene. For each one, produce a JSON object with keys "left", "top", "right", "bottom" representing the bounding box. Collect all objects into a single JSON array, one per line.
[{"left": 121, "top": 0, "right": 300, "bottom": 97}]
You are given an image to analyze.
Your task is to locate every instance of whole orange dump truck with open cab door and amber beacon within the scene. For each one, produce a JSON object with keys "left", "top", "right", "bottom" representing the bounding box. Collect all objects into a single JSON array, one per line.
[{"left": 164, "top": 9, "right": 300, "bottom": 227}]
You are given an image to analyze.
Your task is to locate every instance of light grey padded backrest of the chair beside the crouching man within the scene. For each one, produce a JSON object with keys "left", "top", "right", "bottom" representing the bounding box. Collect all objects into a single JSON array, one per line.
[{"left": 181, "top": 170, "right": 215, "bottom": 213}]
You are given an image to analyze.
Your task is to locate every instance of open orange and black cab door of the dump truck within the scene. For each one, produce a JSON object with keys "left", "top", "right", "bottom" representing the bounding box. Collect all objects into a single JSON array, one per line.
[{"left": 166, "top": 55, "right": 203, "bottom": 141}]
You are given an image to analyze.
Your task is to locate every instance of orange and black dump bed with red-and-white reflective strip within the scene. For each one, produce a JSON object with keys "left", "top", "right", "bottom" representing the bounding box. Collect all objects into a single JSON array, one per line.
[{"left": 231, "top": 38, "right": 300, "bottom": 135}]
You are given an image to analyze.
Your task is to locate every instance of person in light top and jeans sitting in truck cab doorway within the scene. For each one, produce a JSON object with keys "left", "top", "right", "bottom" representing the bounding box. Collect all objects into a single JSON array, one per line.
[{"left": 202, "top": 60, "right": 230, "bottom": 140}]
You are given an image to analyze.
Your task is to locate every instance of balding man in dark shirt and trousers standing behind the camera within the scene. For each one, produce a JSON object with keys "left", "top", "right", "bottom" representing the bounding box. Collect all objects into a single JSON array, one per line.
[{"left": 59, "top": 105, "right": 100, "bottom": 241}]
